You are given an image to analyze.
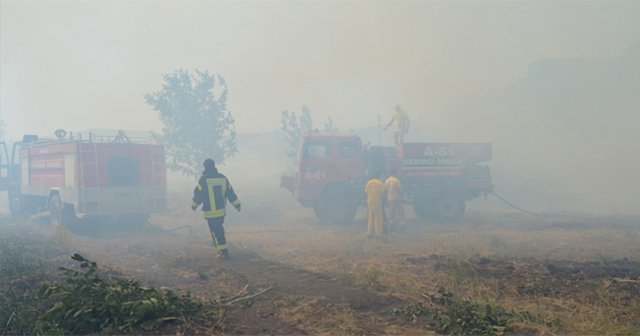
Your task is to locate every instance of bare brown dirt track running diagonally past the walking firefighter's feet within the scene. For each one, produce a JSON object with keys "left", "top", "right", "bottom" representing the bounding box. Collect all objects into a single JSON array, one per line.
[{"left": 18, "top": 220, "right": 418, "bottom": 335}]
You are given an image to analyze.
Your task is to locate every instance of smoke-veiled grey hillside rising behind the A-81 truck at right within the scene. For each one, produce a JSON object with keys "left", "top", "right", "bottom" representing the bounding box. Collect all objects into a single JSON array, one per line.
[{"left": 416, "top": 43, "right": 640, "bottom": 214}]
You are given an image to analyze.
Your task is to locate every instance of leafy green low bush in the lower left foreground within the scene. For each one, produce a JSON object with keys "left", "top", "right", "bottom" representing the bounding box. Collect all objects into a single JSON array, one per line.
[{"left": 34, "top": 253, "right": 203, "bottom": 334}]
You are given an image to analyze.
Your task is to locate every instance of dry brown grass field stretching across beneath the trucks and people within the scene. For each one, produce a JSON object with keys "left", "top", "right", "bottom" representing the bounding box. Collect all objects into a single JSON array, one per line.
[{"left": 0, "top": 190, "right": 640, "bottom": 335}]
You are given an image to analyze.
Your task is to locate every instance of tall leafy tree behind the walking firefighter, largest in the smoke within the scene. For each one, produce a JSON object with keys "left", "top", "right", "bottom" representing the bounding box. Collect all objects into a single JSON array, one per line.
[{"left": 144, "top": 69, "right": 238, "bottom": 176}]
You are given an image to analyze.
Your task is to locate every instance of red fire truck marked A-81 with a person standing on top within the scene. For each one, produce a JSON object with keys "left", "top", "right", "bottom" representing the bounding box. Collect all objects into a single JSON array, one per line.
[{"left": 281, "top": 134, "right": 493, "bottom": 222}]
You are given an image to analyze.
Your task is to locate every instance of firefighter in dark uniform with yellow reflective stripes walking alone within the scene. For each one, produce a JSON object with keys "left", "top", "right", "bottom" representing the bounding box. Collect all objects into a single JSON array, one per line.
[{"left": 191, "top": 159, "right": 241, "bottom": 260}]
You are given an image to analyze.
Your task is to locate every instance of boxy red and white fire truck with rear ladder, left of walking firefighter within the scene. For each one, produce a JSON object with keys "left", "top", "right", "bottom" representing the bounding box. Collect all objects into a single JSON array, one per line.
[{"left": 0, "top": 130, "right": 167, "bottom": 224}]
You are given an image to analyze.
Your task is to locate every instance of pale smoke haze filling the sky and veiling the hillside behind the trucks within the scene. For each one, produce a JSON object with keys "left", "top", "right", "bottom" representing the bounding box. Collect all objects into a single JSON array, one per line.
[{"left": 0, "top": 1, "right": 640, "bottom": 214}]
